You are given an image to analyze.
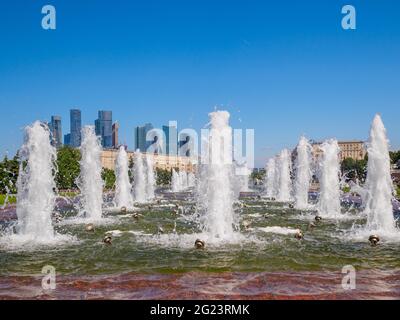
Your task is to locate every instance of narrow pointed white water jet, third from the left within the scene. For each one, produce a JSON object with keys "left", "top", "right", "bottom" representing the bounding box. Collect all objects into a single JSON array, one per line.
[{"left": 115, "top": 146, "right": 133, "bottom": 208}]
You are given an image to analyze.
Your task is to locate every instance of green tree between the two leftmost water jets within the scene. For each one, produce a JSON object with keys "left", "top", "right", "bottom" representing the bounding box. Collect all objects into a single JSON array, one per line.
[{"left": 56, "top": 146, "right": 81, "bottom": 190}]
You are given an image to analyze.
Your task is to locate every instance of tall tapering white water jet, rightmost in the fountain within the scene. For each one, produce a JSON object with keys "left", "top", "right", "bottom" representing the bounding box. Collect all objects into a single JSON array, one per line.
[{"left": 364, "top": 115, "right": 397, "bottom": 234}]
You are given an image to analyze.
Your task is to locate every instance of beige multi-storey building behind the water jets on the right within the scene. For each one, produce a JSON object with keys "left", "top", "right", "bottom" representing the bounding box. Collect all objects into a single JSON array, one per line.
[{"left": 312, "top": 141, "right": 367, "bottom": 161}]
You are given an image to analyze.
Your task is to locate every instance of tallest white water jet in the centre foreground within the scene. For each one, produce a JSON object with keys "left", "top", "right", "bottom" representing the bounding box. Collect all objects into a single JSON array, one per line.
[{"left": 198, "top": 111, "right": 237, "bottom": 241}]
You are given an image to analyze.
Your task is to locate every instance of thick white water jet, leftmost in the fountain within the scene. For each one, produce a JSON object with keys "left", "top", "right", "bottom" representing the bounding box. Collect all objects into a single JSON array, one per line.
[{"left": 17, "top": 121, "right": 57, "bottom": 242}]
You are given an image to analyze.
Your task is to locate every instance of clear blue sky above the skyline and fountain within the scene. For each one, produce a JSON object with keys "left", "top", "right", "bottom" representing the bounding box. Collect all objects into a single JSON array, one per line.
[{"left": 0, "top": 0, "right": 400, "bottom": 166}]
